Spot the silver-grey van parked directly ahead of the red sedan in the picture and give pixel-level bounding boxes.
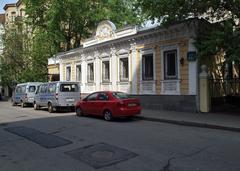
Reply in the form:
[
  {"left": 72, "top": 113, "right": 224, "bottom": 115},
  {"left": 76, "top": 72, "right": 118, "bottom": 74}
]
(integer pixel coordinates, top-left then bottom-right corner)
[{"left": 33, "top": 81, "right": 81, "bottom": 113}]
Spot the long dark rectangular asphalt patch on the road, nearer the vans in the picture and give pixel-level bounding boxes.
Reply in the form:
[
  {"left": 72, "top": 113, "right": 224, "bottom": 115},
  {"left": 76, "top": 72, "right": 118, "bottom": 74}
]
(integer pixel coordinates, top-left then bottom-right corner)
[{"left": 5, "top": 126, "right": 72, "bottom": 148}]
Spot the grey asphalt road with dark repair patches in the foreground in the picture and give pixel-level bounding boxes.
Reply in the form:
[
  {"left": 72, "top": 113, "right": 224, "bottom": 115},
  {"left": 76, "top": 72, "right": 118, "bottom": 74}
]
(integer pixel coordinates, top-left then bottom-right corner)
[{"left": 0, "top": 102, "right": 240, "bottom": 171}]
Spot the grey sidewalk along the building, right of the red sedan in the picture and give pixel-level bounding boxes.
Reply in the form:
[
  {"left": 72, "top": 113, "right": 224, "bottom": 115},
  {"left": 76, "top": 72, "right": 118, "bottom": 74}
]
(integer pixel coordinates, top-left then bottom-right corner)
[{"left": 139, "top": 109, "right": 240, "bottom": 132}]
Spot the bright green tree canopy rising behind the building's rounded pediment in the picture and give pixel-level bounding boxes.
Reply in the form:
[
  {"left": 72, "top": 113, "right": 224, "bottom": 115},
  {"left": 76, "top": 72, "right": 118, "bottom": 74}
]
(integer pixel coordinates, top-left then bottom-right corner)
[{"left": 24, "top": 0, "right": 140, "bottom": 51}]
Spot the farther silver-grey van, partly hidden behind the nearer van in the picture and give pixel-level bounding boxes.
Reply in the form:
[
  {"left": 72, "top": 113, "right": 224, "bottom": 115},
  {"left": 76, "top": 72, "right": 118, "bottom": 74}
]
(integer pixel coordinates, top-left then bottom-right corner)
[{"left": 12, "top": 82, "right": 41, "bottom": 107}]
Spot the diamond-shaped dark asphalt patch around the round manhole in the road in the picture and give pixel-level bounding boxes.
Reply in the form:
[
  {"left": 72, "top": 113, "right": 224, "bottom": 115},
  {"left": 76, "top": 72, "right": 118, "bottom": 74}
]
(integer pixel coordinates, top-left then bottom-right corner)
[{"left": 66, "top": 143, "right": 137, "bottom": 169}]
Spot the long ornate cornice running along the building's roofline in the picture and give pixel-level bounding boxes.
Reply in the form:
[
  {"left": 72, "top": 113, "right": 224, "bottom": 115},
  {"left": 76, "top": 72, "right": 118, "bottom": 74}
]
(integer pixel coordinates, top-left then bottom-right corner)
[{"left": 52, "top": 18, "right": 206, "bottom": 62}]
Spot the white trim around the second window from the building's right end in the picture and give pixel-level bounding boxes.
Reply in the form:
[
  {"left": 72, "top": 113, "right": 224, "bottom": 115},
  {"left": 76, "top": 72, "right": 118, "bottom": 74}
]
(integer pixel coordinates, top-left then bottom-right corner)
[{"left": 140, "top": 49, "right": 156, "bottom": 82}]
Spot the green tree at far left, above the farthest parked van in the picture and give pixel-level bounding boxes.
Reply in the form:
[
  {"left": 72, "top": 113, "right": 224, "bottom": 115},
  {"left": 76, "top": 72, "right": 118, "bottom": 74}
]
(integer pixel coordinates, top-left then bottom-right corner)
[{"left": 0, "top": 18, "right": 31, "bottom": 87}]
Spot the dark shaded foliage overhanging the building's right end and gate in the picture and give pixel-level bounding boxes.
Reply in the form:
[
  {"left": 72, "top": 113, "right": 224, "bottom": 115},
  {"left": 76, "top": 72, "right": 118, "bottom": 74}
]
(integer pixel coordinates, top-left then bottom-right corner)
[{"left": 138, "top": 0, "right": 240, "bottom": 68}]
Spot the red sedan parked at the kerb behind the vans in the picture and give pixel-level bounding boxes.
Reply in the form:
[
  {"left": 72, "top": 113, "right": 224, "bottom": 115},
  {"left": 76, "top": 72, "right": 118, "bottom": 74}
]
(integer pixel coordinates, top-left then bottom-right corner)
[{"left": 75, "top": 91, "right": 142, "bottom": 121}]
